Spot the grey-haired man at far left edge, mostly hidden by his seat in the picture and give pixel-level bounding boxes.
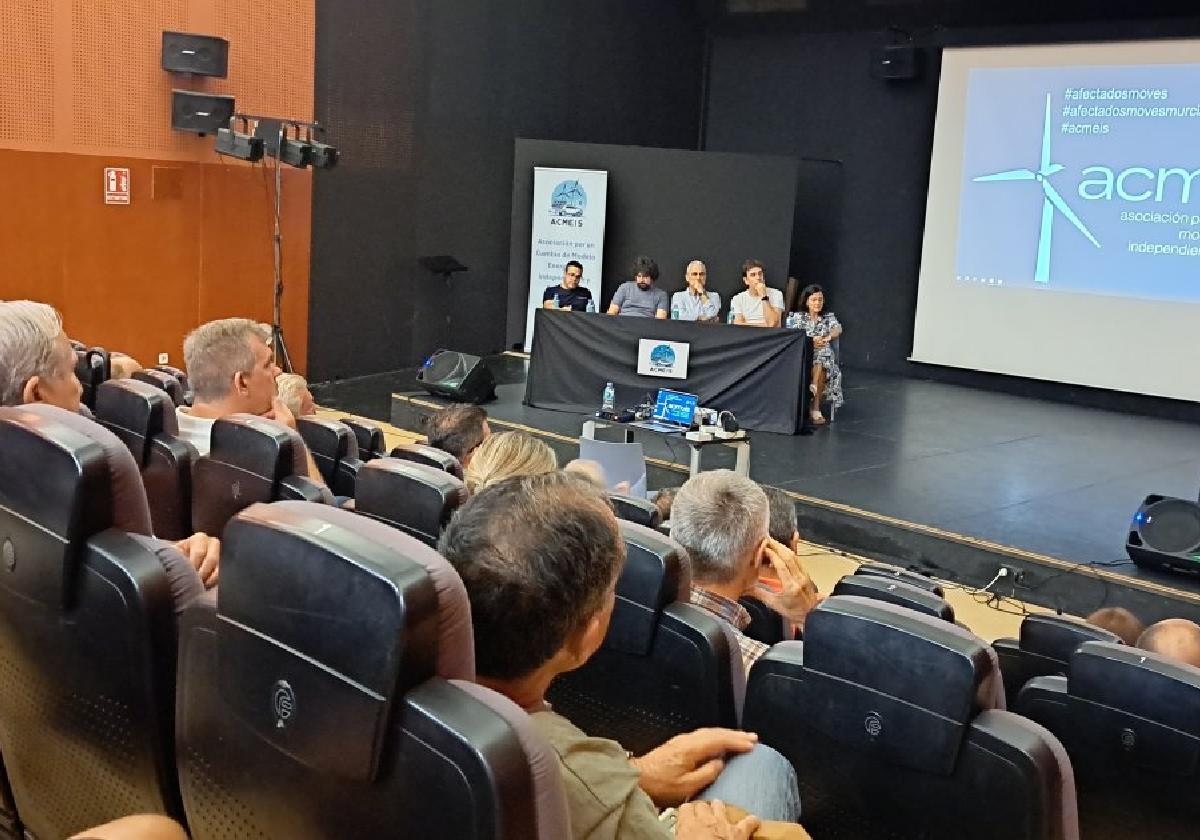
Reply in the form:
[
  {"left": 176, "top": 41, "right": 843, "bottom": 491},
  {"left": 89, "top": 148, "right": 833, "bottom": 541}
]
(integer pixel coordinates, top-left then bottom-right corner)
[{"left": 0, "top": 300, "right": 214, "bottom": 592}]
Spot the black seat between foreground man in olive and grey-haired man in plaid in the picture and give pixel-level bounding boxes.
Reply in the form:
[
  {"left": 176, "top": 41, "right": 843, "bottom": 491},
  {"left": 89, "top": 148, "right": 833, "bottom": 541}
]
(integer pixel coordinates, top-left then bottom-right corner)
[{"left": 547, "top": 522, "right": 745, "bottom": 754}]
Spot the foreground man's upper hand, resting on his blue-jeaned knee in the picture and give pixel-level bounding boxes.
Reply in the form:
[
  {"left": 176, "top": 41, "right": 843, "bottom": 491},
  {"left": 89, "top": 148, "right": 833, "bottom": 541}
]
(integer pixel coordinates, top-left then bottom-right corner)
[{"left": 630, "top": 728, "right": 758, "bottom": 808}]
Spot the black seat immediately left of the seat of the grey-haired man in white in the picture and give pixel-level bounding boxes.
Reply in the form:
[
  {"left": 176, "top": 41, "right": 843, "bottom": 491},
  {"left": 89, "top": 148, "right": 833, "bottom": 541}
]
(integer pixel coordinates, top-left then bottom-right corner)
[{"left": 96, "top": 379, "right": 196, "bottom": 541}]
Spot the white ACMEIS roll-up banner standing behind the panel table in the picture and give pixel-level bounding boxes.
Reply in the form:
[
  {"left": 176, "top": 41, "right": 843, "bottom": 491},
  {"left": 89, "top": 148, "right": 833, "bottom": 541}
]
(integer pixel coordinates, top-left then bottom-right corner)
[{"left": 526, "top": 167, "right": 608, "bottom": 352}]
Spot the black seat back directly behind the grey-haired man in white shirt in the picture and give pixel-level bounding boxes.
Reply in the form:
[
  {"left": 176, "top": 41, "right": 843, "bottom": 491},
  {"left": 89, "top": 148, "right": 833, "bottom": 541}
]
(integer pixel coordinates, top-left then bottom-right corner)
[{"left": 192, "top": 414, "right": 334, "bottom": 534}]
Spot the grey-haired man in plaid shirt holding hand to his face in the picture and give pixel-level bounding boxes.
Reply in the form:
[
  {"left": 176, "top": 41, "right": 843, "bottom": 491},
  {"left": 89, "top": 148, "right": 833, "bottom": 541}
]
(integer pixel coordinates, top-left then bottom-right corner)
[{"left": 671, "top": 469, "right": 818, "bottom": 674}]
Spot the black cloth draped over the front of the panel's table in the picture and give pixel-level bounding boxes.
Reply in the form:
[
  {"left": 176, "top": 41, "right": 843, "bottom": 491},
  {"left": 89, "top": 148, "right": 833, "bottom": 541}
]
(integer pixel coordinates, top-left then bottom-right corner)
[{"left": 524, "top": 310, "right": 812, "bottom": 434}]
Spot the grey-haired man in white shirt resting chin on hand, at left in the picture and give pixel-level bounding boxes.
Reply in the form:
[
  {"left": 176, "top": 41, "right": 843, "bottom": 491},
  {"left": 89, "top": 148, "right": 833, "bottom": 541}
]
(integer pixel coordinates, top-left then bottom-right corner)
[{"left": 175, "top": 318, "right": 325, "bottom": 486}]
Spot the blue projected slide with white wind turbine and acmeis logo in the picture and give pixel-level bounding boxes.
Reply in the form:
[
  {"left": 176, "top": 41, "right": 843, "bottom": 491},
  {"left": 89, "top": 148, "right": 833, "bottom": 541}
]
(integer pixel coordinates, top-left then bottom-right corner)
[{"left": 955, "top": 65, "right": 1200, "bottom": 302}]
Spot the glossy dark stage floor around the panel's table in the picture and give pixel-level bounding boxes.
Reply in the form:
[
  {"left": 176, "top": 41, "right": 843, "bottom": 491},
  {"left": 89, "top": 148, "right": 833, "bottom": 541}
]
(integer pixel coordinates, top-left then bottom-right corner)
[{"left": 314, "top": 354, "right": 1200, "bottom": 604}]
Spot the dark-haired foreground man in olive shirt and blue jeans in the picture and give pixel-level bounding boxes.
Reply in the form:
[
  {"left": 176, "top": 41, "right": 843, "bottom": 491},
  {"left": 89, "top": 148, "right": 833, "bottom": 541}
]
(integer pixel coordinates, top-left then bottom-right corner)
[{"left": 439, "top": 472, "right": 799, "bottom": 840}]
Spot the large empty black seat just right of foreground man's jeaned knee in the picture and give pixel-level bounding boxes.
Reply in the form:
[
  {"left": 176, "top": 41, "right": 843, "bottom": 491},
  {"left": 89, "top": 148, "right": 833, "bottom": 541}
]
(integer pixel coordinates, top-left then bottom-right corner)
[{"left": 743, "top": 596, "right": 1079, "bottom": 840}]
